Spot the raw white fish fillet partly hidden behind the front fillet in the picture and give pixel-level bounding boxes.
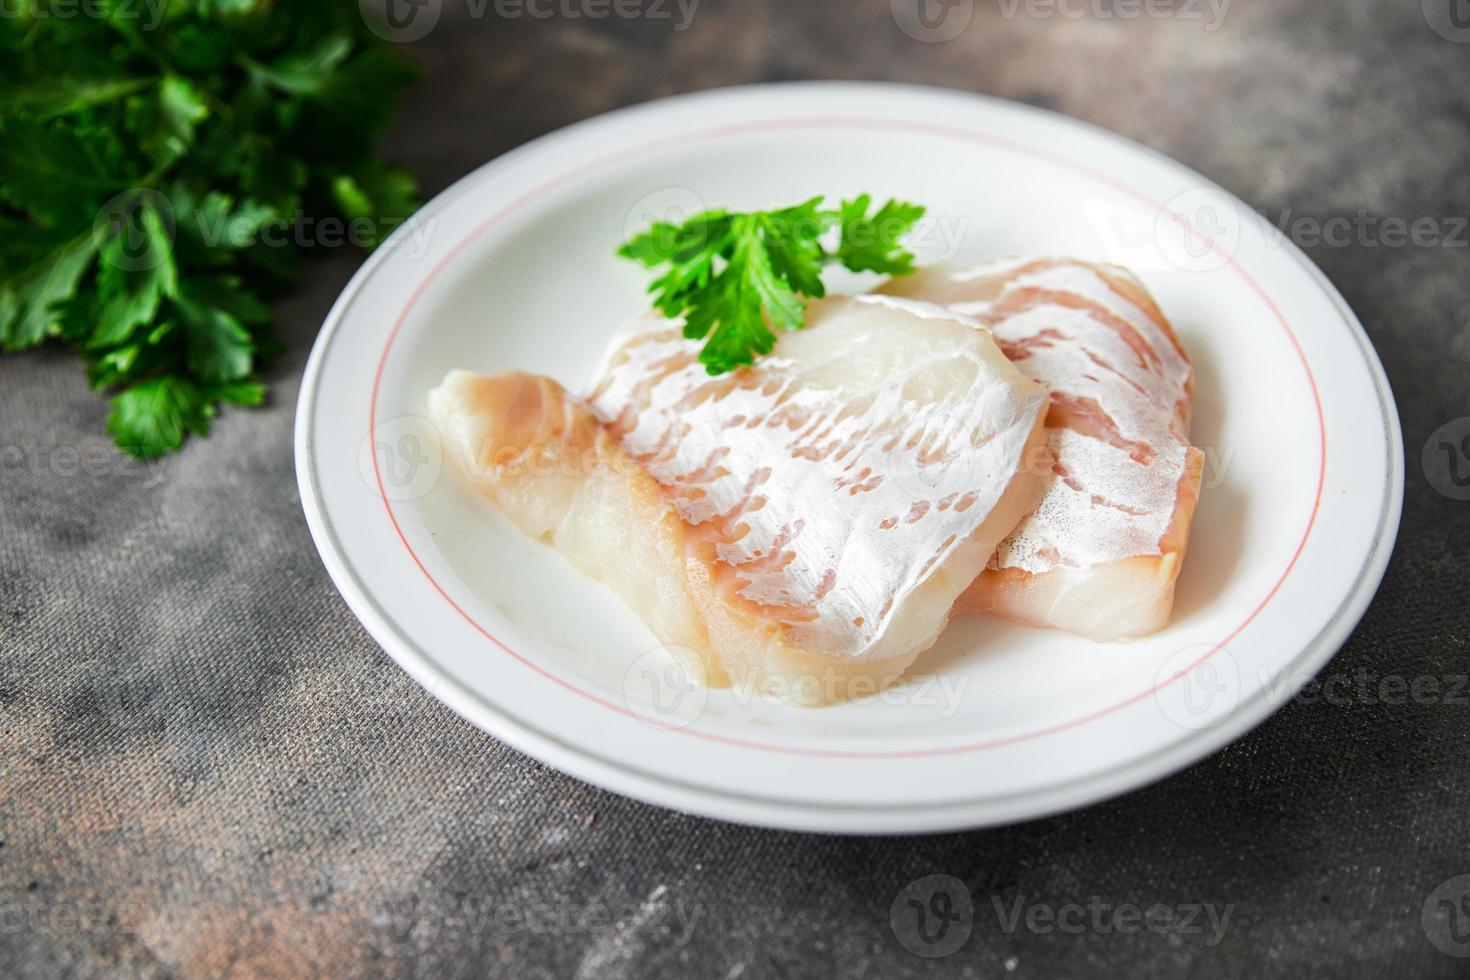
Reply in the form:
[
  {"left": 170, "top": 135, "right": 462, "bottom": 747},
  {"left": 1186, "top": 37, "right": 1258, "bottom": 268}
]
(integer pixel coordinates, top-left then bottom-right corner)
[{"left": 882, "top": 259, "right": 1204, "bottom": 641}]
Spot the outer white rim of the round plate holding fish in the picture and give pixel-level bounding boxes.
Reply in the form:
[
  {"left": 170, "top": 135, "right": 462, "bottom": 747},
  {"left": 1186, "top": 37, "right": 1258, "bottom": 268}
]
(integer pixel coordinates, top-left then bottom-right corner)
[{"left": 294, "top": 82, "right": 1404, "bottom": 833}]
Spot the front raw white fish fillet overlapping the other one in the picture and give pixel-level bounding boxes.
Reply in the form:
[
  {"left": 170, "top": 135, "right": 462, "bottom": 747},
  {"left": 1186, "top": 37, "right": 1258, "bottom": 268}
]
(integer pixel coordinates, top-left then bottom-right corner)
[{"left": 429, "top": 297, "right": 1048, "bottom": 704}]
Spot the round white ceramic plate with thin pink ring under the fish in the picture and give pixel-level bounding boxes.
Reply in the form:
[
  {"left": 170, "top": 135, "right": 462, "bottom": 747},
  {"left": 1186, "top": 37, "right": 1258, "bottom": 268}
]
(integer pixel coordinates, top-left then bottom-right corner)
[{"left": 297, "top": 84, "right": 1402, "bottom": 832}]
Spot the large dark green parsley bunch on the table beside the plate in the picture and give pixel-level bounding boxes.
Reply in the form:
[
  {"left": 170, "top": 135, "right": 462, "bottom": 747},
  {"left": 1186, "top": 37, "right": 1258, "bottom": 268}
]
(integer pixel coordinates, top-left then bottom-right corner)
[{"left": 0, "top": 0, "right": 416, "bottom": 458}]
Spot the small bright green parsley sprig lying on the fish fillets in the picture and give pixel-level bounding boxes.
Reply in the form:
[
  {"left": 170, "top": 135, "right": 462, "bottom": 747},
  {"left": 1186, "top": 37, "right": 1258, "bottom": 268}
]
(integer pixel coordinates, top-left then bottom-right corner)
[{"left": 617, "top": 194, "right": 925, "bottom": 375}]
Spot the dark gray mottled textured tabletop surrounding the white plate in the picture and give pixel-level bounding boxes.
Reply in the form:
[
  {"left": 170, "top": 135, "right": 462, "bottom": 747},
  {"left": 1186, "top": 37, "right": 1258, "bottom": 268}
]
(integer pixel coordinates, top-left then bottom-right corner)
[{"left": 0, "top": 0, "right": 1470, "bottom": 979}]
